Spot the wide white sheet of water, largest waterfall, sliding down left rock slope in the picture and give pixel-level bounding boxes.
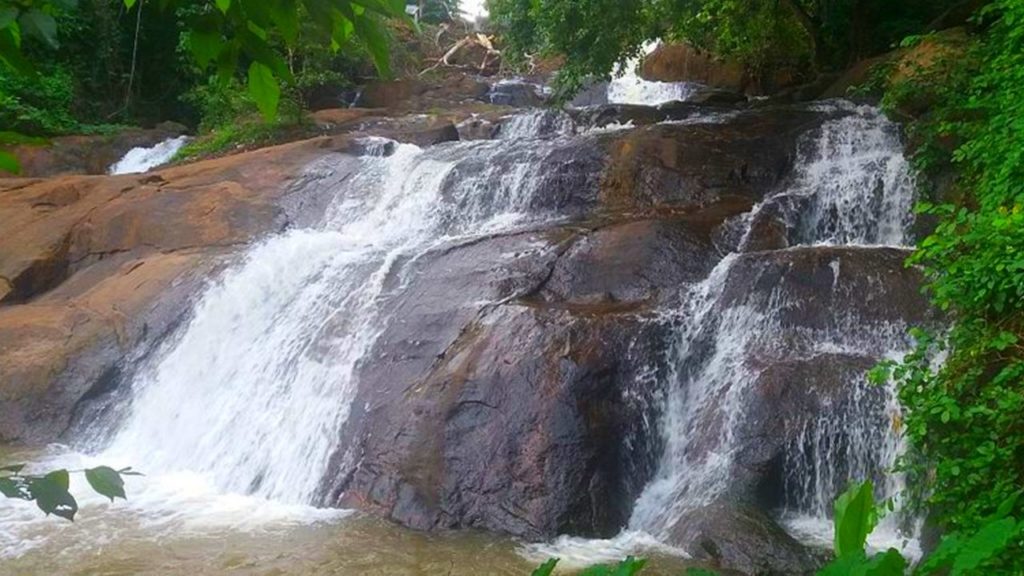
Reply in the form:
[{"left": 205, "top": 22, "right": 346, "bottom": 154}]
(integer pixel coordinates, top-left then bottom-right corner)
[{"left": 96, "top": 124, "right": 589, "bottom": 504}]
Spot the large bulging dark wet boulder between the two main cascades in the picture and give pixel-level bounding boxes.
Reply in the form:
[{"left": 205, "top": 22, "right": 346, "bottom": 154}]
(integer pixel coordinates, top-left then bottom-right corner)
[{"left": 328, "top": 225, "right": 673, "bottom": 539}]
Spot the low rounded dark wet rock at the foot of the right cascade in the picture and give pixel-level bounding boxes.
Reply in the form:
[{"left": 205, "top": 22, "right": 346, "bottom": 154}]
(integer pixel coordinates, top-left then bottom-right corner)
[{"left": 670, "top": 503, "right": 821, "bottom": 576}]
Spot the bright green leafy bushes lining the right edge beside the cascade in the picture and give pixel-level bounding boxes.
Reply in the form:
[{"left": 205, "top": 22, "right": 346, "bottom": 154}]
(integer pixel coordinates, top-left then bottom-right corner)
[{"left": 874, "top": 0, "right": 1024, "bottom": 574}]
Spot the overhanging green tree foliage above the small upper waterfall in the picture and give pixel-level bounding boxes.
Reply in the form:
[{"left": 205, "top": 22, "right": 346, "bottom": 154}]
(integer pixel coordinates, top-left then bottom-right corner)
[{"left": 487, "top": 0, "right": 954, "bottom": 95}]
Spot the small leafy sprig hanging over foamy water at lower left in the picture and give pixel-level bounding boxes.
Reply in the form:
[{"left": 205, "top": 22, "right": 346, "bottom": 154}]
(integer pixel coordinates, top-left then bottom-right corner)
[{"left": 0, "top": 464, "right": 139, "bottom": 521}]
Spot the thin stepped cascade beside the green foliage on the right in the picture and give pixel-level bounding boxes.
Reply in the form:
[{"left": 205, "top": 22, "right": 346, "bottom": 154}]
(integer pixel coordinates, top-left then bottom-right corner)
[{"left": 630, "top": 107, "right": 914, "bottom": 553}]
